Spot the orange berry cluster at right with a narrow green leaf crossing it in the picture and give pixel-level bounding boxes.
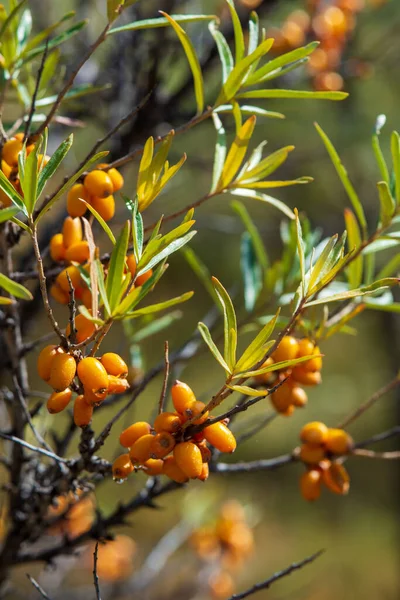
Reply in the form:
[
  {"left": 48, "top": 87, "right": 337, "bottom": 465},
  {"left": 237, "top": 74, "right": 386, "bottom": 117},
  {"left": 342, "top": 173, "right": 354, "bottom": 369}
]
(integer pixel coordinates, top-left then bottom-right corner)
[{"left": 255, "top": 335, "right": 322, "bottom": 416}]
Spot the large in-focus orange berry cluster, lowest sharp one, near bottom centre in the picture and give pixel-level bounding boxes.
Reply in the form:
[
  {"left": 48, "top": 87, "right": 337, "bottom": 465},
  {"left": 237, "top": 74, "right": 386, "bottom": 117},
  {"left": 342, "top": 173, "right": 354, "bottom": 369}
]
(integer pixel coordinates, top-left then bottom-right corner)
[{"left": 112, "top": 381, "right": 236, "bottom": 483}]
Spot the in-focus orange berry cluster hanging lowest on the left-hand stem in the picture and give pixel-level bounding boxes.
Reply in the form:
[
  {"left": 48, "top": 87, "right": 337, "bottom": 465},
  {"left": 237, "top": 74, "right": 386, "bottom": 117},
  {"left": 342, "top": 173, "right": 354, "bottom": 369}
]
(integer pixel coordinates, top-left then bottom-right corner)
[{"left": 37, "top": 344, "right": 129, "bottom": 427}]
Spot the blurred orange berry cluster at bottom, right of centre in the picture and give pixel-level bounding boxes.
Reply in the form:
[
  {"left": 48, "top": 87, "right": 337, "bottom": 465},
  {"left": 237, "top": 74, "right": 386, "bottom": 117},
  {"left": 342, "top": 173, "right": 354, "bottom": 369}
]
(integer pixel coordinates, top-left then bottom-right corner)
[{"left": 190, "top": 500, "right": 254, "bottom": 598}]
